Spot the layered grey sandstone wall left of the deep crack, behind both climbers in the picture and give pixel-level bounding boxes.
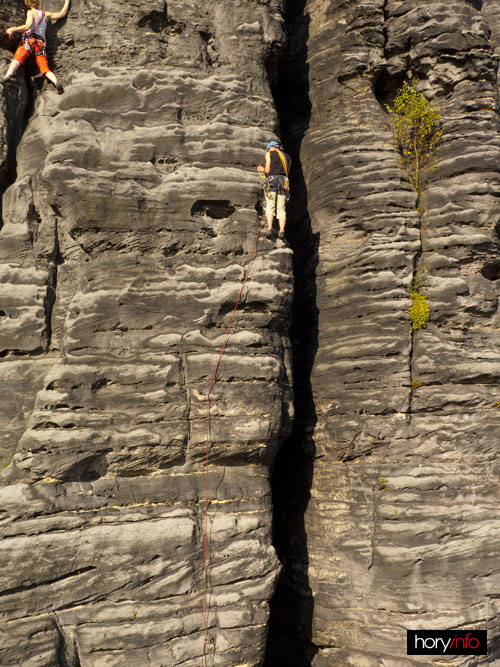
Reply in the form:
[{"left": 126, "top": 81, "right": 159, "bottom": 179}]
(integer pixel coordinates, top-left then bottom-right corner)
[{"left": 0, "top": 0, "right": 292, "bottom": 667}]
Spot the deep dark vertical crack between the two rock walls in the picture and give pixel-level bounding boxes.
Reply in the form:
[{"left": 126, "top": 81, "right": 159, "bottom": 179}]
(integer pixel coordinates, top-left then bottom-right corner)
[{"left": 264, "top": 0, "right": 319, "bottom": 667}]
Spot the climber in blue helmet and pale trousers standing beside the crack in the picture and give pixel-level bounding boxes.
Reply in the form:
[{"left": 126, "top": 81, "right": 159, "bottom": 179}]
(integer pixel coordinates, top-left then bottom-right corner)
[{"left": 257, "top": 141, "right": 292, "bottom": 241}]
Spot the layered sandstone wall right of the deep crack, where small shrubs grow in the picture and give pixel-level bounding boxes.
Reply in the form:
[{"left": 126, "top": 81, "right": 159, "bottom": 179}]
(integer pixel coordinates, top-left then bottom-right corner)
[{"left": 267, "top": 0, "right": 500, "bottom": 667}]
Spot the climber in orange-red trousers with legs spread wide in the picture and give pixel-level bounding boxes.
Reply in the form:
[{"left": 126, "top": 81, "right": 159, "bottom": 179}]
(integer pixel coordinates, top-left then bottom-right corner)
[{"left": 0, "top": 0, "right": 70, "bottom": 94}]
